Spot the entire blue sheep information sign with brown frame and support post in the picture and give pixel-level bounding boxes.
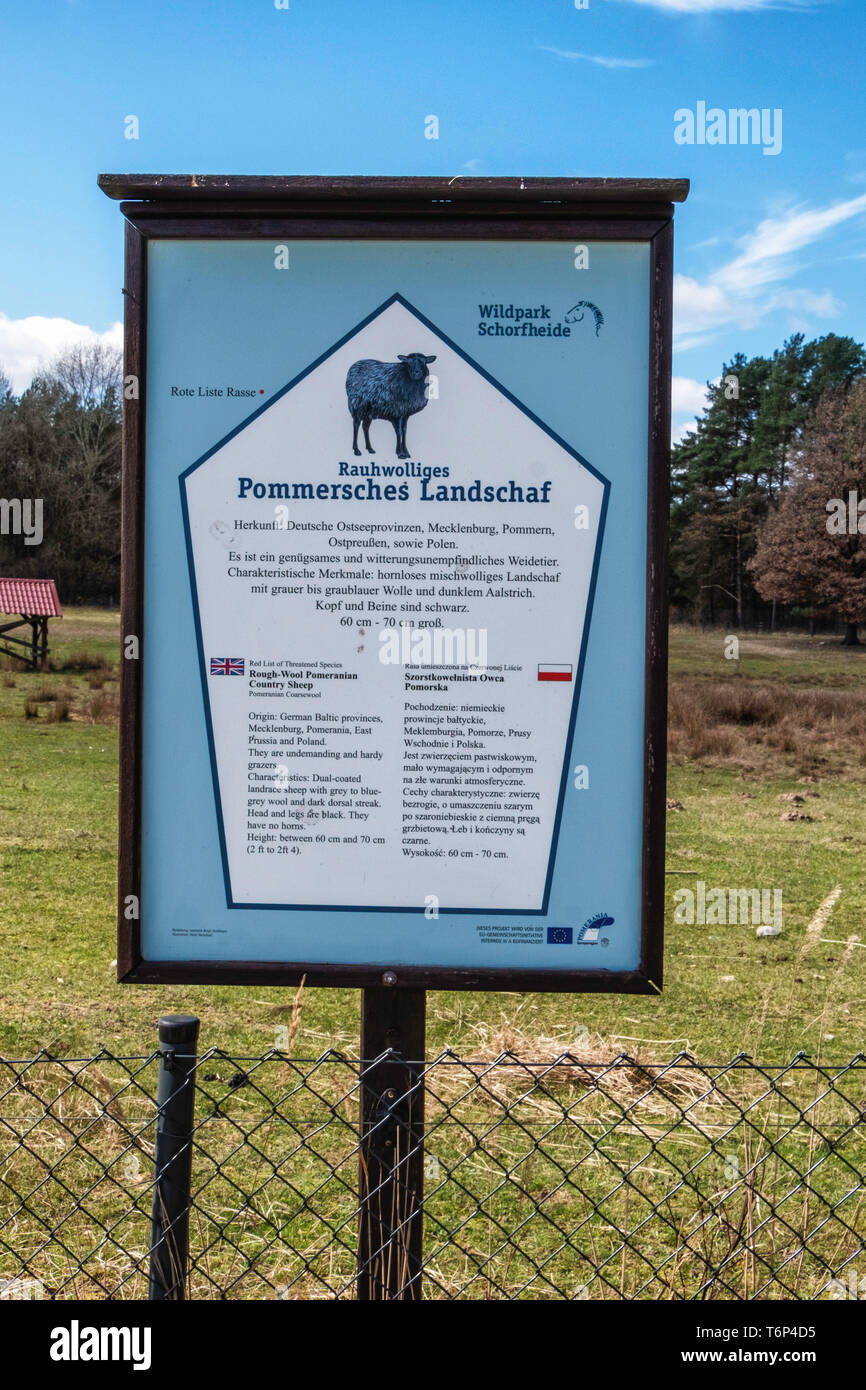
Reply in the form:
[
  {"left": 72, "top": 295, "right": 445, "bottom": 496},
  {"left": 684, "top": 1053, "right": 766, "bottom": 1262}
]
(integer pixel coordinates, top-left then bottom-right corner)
[{"left": 100, "top": 175, "right": 688, "bottom": 1298}]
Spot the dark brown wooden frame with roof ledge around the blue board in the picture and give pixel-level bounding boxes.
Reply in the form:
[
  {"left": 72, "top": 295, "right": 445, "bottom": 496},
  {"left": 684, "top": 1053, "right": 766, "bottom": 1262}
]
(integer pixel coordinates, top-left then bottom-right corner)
[{"left": 99, "top": 174, "right": 688, "bottom": 994}]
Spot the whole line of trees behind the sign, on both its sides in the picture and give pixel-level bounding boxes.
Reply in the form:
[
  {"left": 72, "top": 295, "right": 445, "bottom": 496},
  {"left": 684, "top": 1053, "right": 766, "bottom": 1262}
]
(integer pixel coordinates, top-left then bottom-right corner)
[{"left": 0, "top": 334, "right": 866, "bottom": 641}]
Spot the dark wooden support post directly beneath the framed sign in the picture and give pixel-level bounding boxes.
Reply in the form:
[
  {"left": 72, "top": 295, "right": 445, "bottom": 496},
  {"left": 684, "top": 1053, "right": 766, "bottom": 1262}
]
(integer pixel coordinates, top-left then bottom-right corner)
[{"left": 357, "top": 972, "right": 427, "bottom": 1302}]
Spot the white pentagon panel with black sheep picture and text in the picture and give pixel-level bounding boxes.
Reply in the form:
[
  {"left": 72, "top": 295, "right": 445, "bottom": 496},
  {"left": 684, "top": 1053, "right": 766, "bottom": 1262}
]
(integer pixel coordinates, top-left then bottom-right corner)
[{"left": 181, "top": 296, "right": 606, "bottom": 916}]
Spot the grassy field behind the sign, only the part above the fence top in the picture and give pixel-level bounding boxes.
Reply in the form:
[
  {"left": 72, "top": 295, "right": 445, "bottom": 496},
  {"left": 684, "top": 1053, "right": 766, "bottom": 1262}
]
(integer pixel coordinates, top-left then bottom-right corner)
[{"left": 0, "top": 609, "right": 866, "bottom": 1061}]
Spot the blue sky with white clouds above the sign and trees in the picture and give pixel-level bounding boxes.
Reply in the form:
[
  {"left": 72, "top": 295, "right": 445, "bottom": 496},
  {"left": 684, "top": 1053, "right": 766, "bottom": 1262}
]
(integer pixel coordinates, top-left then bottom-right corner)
[{"left": 0, "top": 0, "right": 866, "bottom": 434}]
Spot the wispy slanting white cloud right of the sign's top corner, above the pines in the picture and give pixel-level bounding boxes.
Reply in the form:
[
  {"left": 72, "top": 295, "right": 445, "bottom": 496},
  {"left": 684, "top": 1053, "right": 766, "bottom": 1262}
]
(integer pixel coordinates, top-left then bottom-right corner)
[{"left": 674, "top": 195, "right": 866, "bottom": 350}]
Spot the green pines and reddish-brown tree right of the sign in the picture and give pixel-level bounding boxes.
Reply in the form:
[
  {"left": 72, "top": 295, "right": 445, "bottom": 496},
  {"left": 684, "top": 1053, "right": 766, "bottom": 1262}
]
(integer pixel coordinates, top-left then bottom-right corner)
[{"left": 671, "top": 334, "right": 866, "bottom": 641}]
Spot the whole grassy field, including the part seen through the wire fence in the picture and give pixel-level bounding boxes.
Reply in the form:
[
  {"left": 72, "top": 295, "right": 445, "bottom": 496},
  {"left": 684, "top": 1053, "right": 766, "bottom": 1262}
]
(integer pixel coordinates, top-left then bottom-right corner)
[{"left": 0, "top": 609, "right": 866, "bottom": 1298}]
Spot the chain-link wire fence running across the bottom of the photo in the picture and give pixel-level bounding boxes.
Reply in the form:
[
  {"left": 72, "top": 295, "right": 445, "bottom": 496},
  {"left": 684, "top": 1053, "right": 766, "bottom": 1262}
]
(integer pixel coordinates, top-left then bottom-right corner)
[{"left": 0, "top": 1049, "right": 866, "bottom": 1300}]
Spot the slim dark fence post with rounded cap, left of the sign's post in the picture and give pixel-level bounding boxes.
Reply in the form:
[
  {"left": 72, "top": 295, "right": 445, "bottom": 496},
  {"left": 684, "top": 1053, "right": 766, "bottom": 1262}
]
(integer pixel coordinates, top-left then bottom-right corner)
[{"left": 147, "top": 1013, "right": 199, "bottom": 1301}]
